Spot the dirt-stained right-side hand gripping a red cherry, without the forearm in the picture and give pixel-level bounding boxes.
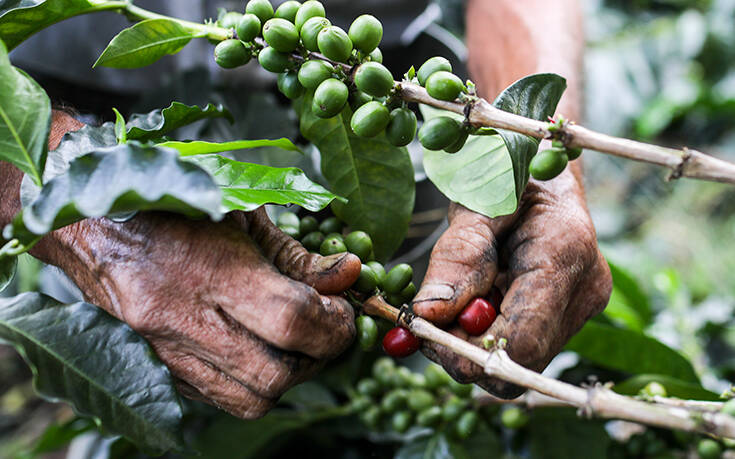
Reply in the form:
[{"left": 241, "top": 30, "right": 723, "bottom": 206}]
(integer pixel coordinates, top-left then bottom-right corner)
[{"left": 414, "top": 168, "right": 612, "bottom": 398}]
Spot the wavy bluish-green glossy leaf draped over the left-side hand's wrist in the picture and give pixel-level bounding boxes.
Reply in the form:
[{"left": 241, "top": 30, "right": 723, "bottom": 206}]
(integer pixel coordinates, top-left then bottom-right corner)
[{"left": 6, "top": 142, "right": 222, "bottom": 244}]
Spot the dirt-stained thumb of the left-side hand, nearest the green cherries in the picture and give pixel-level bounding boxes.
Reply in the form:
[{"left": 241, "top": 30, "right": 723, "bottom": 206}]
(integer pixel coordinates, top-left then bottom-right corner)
[{"left": 237, "top": 207, "right": 361, "bottom": 295}]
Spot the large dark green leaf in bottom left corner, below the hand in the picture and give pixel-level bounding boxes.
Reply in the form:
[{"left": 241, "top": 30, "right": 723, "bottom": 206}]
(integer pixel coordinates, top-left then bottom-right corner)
[{"left": 0, "top": 293, "right": 182, "bottom": 453}]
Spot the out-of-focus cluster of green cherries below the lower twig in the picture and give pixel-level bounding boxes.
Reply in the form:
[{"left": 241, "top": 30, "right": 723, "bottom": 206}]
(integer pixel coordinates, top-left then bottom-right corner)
[{"left": 350, "top": 357, "right": 479, "bottom": 439}]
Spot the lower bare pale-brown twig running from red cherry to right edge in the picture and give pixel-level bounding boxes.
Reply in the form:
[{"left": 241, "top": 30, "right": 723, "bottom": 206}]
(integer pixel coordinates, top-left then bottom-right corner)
[{"left": 363, "top": 295, "right": 735, "bottom": 438}]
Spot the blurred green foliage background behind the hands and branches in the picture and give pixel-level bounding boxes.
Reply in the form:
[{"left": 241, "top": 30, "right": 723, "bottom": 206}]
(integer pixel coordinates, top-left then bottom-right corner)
[{"left": 0, "top": 0, "right": 735, "bottom": 459}]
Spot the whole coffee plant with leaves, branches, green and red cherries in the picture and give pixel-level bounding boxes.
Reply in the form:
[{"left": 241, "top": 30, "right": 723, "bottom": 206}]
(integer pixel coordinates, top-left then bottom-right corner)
[{"left": 0, "top": 0, "right": 735, "bottom": 457}]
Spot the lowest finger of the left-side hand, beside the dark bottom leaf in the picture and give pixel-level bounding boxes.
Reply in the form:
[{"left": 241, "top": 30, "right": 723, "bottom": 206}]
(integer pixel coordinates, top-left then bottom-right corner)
[{"left": 161, "top": 346, "right": 276, "bottom": 419}]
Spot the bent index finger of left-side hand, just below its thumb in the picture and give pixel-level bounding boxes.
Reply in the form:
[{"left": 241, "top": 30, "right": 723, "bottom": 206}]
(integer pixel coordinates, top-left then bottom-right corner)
[{"left": 205, "top": 268, "right": 355, "bottom": 359}]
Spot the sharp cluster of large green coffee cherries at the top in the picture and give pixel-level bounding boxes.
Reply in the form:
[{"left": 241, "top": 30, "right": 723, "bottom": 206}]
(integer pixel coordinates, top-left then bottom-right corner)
[{"left": 214, "top": 0, "right": 417, "bottom": 146}]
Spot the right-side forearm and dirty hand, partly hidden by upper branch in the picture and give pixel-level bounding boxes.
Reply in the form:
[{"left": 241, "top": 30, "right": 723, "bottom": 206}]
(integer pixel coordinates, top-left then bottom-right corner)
[{"left": 414, "top": 0, "right": 611, "bottom": 397}]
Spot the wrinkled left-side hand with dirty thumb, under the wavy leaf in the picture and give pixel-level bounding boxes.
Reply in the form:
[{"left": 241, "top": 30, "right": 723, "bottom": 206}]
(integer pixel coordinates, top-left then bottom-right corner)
[{"left": 0, "top": 112, "right": 361, "bottom": 418}]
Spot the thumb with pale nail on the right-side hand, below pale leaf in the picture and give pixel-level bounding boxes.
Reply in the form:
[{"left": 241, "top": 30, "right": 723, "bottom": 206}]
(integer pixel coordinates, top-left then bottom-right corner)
[{"left": 413, "top": 205, "right": 514, "bottom": 324}]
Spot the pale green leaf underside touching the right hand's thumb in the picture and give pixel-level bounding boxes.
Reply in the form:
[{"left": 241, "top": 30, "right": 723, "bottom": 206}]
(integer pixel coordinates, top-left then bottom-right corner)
[{"left": 420, "top": 105, "right": 517, "bottom": 217}]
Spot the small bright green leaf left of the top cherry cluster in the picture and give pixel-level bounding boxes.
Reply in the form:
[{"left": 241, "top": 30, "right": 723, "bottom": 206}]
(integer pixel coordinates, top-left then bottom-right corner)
[{"left": 94, "top": 18, "right": 200, "bottom": 69}]
